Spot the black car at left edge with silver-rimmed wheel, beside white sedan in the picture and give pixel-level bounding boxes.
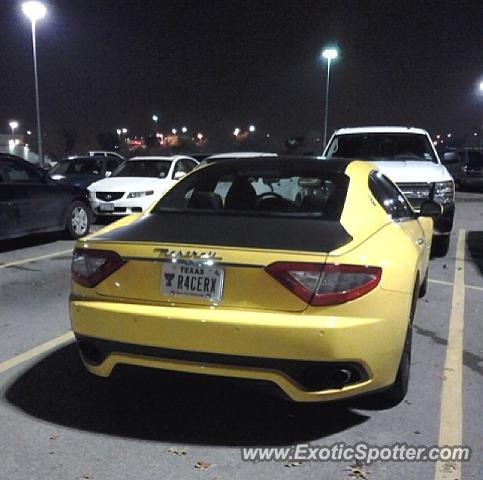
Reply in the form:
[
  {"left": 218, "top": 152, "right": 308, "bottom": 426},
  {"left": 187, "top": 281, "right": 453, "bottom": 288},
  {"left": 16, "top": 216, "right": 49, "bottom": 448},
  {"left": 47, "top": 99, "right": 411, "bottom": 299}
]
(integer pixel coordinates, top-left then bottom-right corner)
[{"left": 0, "top": 154, "right": 92, "bottom": 240}]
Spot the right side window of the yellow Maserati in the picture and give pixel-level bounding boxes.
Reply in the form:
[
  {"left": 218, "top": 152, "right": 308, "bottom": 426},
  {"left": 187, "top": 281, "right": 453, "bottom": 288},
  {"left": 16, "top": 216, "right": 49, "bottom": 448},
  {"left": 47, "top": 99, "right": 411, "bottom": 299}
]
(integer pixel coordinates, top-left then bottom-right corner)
[{"left": 369, "top": 172, "right": 414, "bottom": 220}]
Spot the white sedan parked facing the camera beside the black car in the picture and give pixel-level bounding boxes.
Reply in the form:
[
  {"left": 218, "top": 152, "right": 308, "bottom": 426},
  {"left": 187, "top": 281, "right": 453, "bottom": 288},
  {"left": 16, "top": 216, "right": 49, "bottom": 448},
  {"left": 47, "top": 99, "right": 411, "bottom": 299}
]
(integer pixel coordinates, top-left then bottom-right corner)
[{"left": 88, "top": 155, "right": 198, "bottom": 216}]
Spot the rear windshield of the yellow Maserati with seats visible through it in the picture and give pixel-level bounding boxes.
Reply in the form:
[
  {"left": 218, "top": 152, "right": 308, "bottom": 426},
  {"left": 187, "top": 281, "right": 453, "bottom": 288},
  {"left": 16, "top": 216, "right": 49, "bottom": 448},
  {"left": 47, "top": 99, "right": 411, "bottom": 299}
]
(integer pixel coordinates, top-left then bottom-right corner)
[{"left": 153, "top": 161, "right": 349, "bottom": 221}]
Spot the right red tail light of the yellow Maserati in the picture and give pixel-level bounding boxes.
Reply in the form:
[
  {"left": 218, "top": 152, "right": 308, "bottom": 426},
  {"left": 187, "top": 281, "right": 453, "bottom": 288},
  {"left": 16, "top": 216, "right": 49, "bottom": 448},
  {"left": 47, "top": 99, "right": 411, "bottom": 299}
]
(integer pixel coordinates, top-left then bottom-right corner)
[{"left": 265, "top": 262, "right": 382, "bottom": 306}]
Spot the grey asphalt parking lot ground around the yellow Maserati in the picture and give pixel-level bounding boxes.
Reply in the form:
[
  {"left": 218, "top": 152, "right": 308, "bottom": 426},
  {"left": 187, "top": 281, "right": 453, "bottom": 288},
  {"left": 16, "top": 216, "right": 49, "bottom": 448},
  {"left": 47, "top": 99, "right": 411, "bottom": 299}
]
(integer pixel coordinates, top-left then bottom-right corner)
[{"left": 0, "top": 192, "right": 483, "bottom": 480}]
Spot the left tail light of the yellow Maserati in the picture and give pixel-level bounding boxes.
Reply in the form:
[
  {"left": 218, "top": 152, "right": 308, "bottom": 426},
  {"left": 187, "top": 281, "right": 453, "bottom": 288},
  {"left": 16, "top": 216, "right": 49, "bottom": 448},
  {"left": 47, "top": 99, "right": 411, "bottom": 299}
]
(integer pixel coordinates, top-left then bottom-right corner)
[{"left": 71, "top": 248, "right": 126, "bottom": 288}]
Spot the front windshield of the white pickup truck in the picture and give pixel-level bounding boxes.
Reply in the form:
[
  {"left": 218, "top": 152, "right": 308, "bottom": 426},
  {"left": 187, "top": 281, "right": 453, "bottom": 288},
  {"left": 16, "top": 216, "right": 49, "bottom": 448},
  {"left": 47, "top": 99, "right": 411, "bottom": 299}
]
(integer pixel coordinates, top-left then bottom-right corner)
[{"left": 326, "top": 133, "right": 437, "bottom": 163}]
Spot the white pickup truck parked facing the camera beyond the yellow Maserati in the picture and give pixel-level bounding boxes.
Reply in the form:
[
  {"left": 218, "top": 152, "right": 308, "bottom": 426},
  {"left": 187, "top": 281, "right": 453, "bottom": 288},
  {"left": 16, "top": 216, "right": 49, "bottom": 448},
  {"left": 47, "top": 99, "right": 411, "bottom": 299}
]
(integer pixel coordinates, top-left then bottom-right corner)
[{"left": 323, "top": 127, "right": 455, "bottom": 256}]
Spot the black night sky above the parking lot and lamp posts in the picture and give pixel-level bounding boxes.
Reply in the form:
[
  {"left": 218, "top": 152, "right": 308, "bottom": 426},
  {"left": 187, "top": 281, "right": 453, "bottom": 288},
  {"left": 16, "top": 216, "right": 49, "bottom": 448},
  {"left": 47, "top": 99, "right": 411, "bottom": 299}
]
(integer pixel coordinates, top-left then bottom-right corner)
[{"left": 0, "top": 0, "right": 483, "bottom": 145}]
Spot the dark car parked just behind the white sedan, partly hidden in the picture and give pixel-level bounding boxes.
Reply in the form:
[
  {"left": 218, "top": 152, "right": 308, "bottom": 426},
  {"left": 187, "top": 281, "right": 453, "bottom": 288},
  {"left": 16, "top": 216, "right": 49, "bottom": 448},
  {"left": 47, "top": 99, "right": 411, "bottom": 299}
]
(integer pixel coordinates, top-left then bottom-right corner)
[{"left": 49, "top": 156, "right": 122, "bottom": 188}]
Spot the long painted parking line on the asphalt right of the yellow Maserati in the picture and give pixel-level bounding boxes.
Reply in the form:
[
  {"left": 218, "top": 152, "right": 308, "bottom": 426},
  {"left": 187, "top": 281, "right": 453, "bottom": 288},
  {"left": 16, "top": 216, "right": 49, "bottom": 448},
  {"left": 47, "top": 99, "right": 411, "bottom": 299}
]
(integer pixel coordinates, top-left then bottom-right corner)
[{"left": 434, "top": 230, "right": 466, "bottom": 480}]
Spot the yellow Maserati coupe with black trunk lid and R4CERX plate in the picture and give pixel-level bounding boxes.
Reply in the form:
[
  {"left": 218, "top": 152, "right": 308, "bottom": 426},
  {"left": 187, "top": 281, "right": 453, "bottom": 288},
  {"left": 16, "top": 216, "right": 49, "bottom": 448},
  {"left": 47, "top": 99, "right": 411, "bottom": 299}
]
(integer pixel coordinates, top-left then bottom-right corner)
[{"left": 70, "top": 157, "right": 441, "bottom": 405}]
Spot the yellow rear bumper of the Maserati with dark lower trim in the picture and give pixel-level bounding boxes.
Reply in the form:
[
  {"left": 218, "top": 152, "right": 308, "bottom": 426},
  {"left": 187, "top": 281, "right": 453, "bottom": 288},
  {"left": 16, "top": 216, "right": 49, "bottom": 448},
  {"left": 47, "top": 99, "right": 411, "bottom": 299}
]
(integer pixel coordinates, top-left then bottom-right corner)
[{"left": 70, "top": 292, "right": 410, "bottom": 401}]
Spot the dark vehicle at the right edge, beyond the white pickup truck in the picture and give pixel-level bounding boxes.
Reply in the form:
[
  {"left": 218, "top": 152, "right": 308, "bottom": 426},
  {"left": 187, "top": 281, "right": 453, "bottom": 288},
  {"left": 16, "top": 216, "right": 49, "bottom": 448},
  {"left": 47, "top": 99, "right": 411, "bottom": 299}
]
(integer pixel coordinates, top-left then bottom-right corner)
[{"left": 443, "top": 148, "right": 483, "bottom": 188}]
